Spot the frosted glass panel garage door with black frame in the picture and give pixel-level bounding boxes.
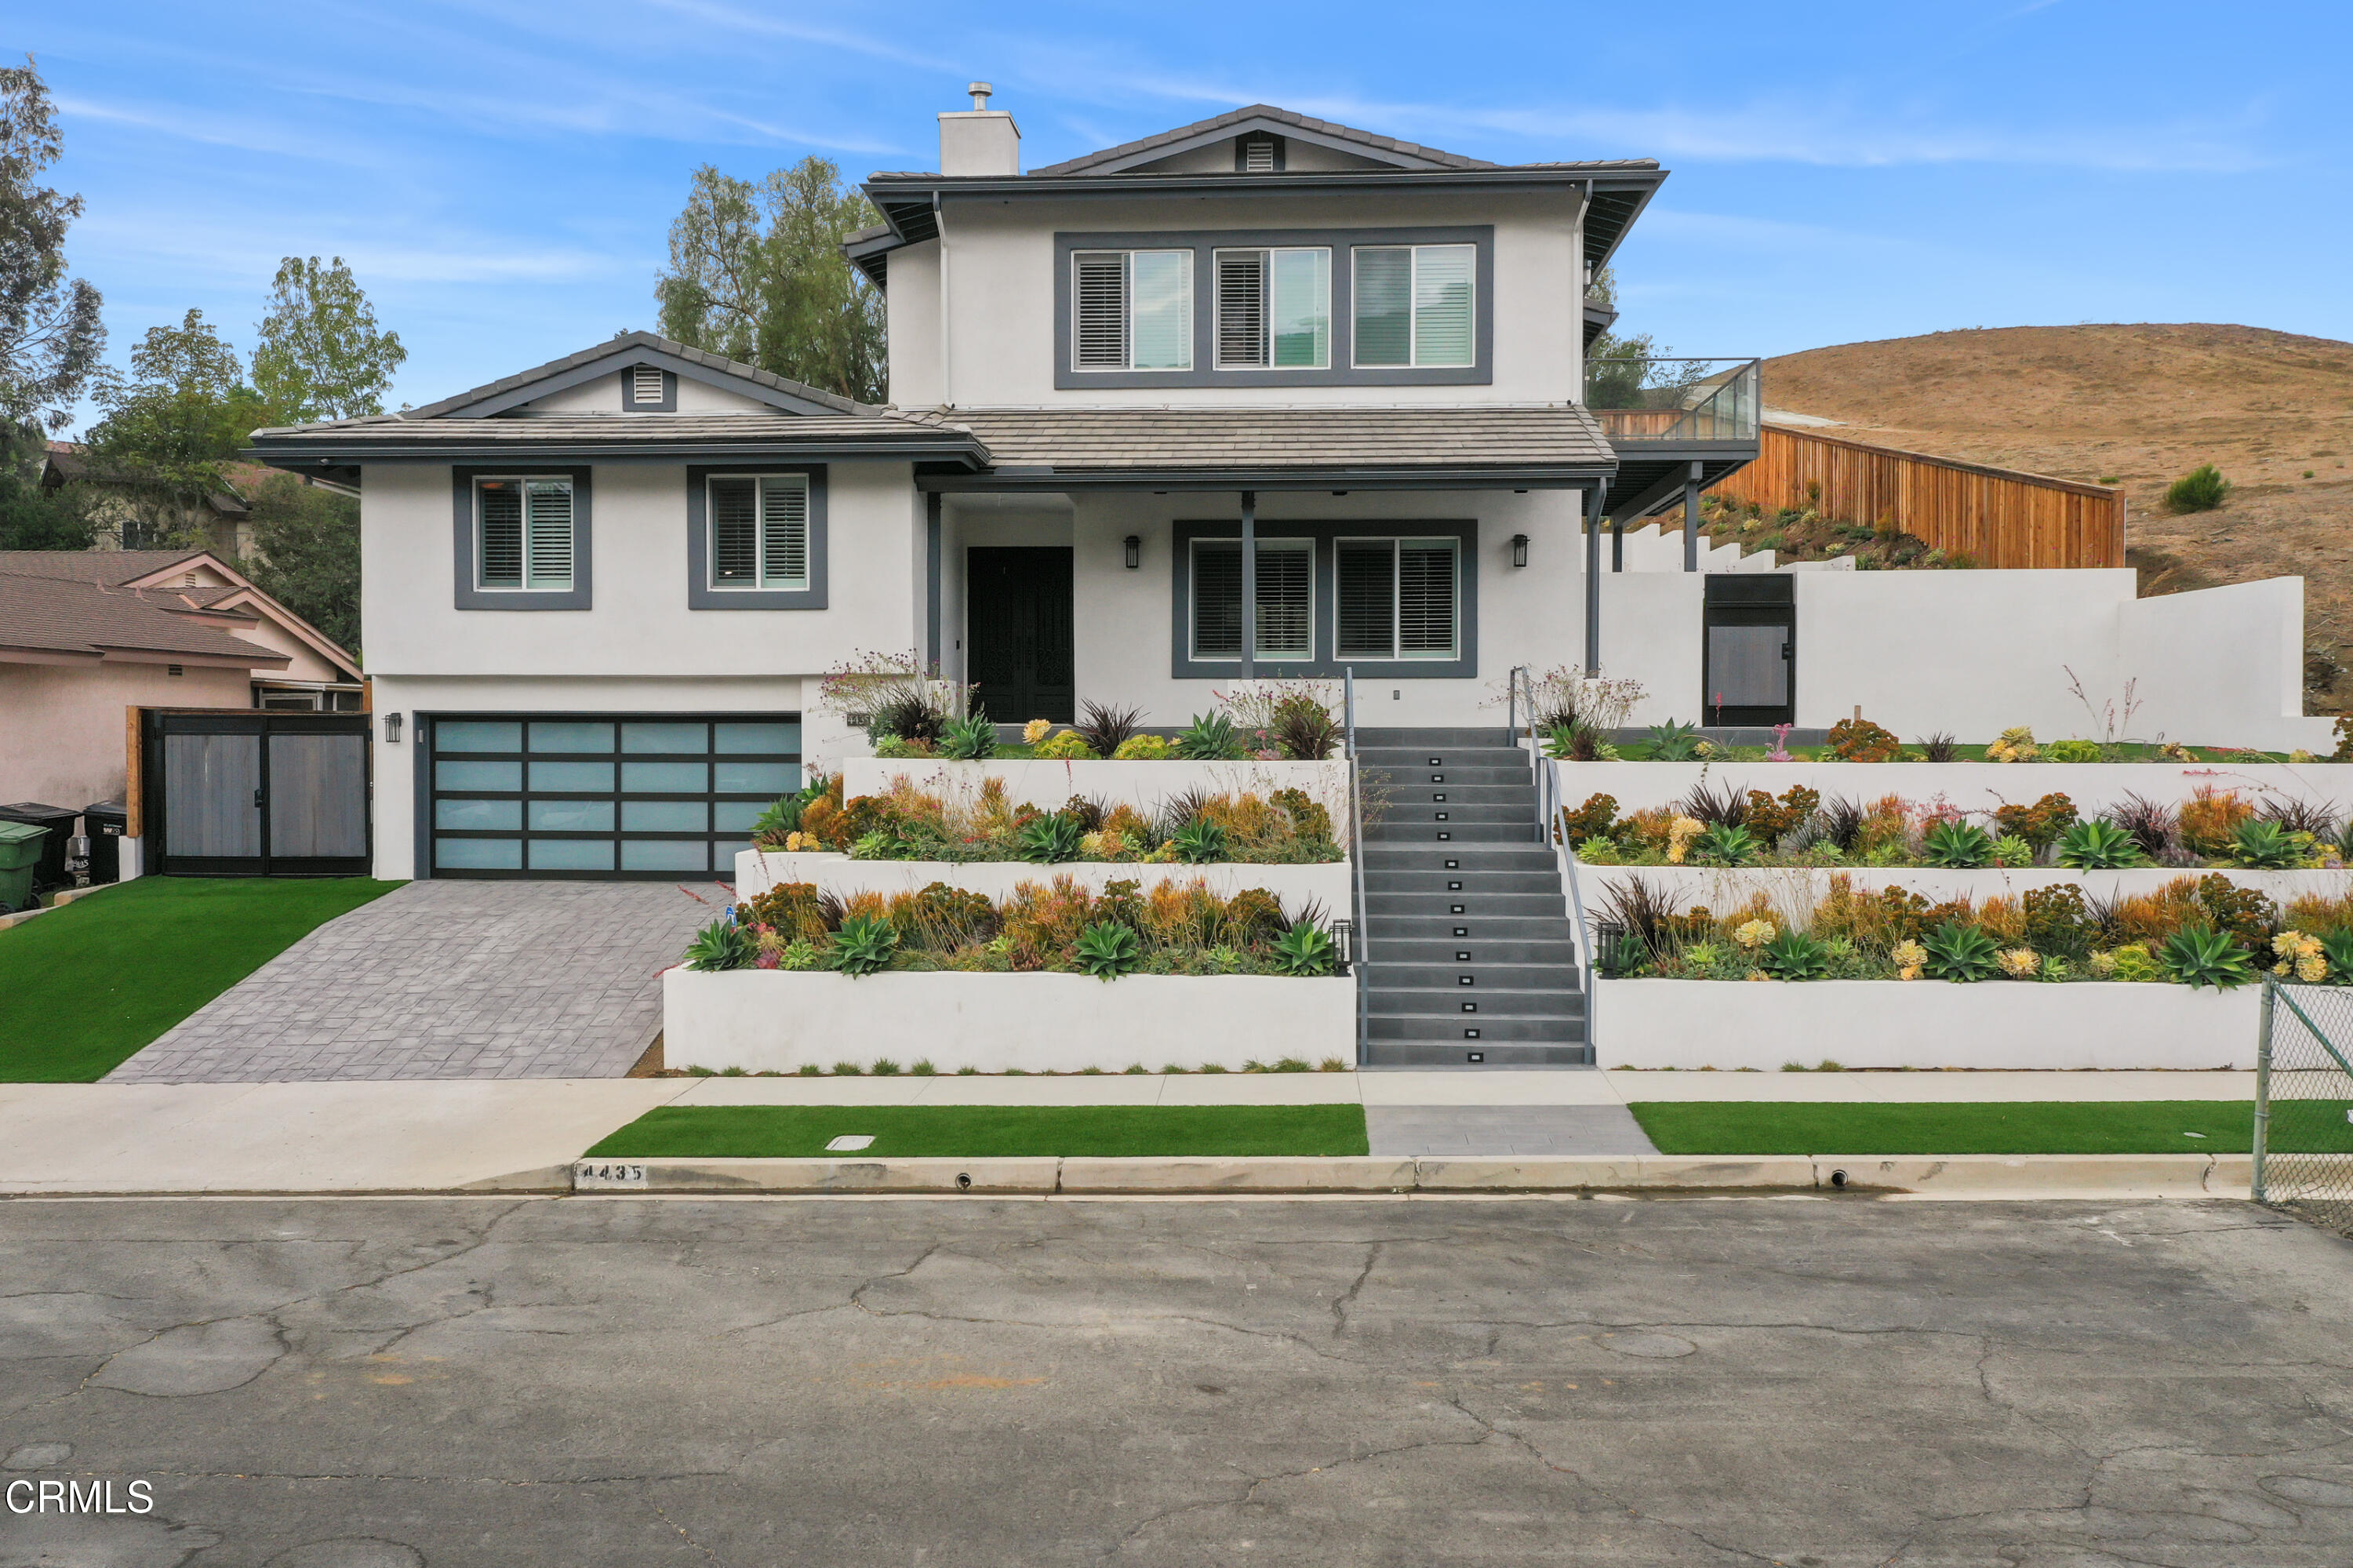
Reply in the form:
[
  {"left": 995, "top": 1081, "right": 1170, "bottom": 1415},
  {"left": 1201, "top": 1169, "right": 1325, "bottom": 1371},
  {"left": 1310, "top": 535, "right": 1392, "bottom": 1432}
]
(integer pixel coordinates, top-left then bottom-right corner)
[{"left": 426, "top": 713, "right": 800, "bottom": 881}]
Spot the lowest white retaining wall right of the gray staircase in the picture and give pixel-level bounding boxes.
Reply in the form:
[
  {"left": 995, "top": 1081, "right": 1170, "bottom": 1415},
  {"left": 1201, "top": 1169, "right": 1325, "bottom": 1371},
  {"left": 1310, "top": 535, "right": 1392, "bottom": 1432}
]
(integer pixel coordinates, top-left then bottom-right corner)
[{"left": 1593, "top": 980, "right": 2261, "bottom": 1068}]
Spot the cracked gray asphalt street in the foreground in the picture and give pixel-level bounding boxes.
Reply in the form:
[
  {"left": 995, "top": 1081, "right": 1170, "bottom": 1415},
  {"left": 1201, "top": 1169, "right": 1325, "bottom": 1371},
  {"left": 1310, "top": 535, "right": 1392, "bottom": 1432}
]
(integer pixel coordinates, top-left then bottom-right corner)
[{"left": 0, "top": 1199, "right": 2353, "bottom": 1568}]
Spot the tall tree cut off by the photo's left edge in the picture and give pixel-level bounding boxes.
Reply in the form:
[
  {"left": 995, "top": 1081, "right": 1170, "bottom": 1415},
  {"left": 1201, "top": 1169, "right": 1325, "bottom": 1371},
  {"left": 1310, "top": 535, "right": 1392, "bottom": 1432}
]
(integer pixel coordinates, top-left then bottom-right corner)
[{"left": 0, "top": 54, "right": 106, "bottom": 431}]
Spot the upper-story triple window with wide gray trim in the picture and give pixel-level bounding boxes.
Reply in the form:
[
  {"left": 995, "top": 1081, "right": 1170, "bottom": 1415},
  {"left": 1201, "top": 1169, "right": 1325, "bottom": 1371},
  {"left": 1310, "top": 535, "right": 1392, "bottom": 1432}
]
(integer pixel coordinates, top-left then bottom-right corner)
[{"left": 1054, "top": 224, "right": 1494, "bottom": 391}]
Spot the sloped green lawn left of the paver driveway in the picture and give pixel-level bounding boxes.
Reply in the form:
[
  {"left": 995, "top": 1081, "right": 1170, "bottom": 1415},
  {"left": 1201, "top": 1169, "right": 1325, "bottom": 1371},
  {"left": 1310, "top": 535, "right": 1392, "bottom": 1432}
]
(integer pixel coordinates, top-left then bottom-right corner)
[{"left": 0, "top": 876, "right": 400, "bottom": 1083}]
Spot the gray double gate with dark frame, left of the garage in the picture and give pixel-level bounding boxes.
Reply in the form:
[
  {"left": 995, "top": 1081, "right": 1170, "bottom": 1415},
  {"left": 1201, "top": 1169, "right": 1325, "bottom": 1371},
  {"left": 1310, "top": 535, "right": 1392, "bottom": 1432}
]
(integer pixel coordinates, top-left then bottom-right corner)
[{"left": 141, "top": 711, "right": 372, "bottom": 876}]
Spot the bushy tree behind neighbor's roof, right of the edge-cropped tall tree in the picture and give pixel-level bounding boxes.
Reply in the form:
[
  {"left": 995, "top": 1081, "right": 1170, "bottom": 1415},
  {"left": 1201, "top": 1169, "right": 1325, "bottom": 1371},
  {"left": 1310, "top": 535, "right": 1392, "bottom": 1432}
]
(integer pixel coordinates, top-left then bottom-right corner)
[{"left": 89, "top": 311, "right": 268, "bottom": 544}]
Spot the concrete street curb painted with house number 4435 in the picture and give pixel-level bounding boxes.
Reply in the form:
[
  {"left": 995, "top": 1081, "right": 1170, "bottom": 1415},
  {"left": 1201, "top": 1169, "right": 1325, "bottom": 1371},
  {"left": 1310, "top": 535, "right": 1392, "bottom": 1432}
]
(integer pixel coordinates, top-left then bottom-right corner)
[{"left": 574, "top": 1154, "right": 2252, "bottom": 1199}]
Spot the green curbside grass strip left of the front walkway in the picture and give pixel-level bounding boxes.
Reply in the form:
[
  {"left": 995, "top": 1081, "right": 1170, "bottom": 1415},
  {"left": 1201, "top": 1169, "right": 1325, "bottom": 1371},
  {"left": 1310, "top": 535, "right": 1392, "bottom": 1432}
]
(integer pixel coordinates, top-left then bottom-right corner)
[{"left": 588, "top": 1104, "right": 1369, "bottom": 1159}]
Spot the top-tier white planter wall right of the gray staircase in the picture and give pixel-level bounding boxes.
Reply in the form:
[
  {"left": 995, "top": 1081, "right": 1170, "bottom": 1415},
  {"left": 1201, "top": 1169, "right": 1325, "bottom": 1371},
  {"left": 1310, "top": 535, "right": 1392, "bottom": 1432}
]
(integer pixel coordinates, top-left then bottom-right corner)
[{"left": 1558, "top": 753, "right": 2353, "bottom": 817}]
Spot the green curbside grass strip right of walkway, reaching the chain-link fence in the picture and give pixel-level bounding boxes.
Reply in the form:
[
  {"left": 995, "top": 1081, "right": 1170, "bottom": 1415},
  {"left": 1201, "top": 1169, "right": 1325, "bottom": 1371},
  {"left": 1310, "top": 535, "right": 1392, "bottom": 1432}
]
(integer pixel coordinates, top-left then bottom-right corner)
[{"left": 1628, "top": 1100, "right": 2353, "bottom": 1154}]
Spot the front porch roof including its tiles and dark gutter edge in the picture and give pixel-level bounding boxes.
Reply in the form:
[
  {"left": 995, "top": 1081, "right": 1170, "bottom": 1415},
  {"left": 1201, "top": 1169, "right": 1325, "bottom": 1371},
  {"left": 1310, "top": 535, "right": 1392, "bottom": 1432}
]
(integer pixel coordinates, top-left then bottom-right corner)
[{"left": 915, "top": 402, "right": 1617, "bottom": 492}]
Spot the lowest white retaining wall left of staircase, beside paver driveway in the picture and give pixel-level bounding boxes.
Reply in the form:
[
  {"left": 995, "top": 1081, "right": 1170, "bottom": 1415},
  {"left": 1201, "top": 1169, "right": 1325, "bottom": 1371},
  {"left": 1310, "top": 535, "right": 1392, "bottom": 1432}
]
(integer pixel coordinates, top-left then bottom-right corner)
[{"left": 661, "top": 970, "right": 1355, "bottom": 1074}]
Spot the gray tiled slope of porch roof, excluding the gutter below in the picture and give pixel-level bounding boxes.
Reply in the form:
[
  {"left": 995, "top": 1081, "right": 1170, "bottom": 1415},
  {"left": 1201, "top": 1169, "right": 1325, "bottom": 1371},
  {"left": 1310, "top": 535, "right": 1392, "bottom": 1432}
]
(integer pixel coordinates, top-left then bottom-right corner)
[{"left": 955, "top": 405, "right": 1617, "bottom": 473}]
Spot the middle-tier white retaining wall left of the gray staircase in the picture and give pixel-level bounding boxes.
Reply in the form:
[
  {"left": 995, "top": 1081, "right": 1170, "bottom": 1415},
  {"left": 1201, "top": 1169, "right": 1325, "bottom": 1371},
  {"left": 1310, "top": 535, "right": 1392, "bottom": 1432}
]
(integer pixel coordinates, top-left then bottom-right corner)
[{"left": 736, "top": 850, "right": 1353, "bottom": 919}]
